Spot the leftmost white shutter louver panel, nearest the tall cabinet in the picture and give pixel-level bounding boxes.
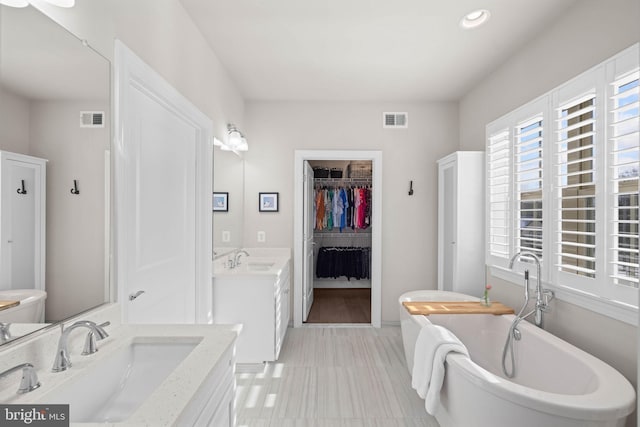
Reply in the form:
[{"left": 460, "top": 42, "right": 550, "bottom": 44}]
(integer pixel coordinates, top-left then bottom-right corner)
[{"left": 487, "top": 130, "right": 511, "bottom": 258}]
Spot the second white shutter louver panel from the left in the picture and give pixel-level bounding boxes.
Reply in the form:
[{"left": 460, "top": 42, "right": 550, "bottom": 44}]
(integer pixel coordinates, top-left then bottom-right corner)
[{"left": 514, "top": 114, "right": 542, "bottom": 259}]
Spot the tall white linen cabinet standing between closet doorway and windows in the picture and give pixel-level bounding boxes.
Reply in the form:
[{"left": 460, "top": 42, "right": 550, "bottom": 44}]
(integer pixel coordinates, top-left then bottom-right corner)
[{"left": 438, "top": 151, "right": 485, "bottom": 296}]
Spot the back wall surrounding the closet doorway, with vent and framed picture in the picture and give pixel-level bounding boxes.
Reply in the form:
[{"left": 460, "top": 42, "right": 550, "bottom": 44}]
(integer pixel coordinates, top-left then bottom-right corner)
[{"left": 244, "top": 101, "right": 458, "bottom": 322}]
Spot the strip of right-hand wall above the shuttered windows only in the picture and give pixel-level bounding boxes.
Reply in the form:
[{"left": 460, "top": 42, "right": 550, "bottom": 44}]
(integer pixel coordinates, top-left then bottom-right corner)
[{"left": 460, "top": 0, "right": 640, "bottom": 150}]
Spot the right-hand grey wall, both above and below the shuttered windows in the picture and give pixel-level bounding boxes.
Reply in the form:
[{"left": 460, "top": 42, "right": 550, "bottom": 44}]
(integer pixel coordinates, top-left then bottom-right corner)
[{"left": 459, "top": 0, "right": 640, "bottom": 426}]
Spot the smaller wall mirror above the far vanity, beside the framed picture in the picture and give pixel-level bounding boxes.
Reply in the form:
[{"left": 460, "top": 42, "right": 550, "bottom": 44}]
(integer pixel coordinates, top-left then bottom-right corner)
[{"left": 212, "top": 147, "right": 244, "bottom": 257}]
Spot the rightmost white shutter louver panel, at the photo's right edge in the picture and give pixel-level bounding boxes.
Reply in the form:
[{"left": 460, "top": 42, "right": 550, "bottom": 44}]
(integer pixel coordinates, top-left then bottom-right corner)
[{"left": 609, "top": 72, "right": 640, "bottom": 288}]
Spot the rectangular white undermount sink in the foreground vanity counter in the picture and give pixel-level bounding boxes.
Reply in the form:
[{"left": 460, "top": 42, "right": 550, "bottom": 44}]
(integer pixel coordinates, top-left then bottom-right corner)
[{"left": 47, "top": 337, "right": 201, "bottom": 423}]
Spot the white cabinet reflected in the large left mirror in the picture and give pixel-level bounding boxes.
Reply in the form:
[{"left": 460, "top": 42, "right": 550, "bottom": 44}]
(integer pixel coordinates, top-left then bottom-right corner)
[{"left": 0, "top": 151, "right": 47, "bottom": 291}]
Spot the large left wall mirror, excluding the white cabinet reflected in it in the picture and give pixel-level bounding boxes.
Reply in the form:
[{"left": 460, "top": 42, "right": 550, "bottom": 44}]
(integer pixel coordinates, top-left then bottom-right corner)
[{"left": 0, "top": 6, "right": 111, "bottom": 341}]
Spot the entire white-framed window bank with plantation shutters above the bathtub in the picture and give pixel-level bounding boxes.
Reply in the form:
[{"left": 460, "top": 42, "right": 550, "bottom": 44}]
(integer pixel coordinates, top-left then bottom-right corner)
[{"left": 486, "top": 44, "right": 640, "bottom": 324}]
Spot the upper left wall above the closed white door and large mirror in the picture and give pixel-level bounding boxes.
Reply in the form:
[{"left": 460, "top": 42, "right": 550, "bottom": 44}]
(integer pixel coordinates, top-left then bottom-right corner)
[{"left": 32, "top": 0, "right": 244, "bottom": 139}]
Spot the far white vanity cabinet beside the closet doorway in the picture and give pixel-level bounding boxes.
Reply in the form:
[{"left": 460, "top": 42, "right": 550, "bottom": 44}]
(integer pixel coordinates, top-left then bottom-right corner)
[{"left": 213, "top": 257, "right": 290, "bottom": 364}]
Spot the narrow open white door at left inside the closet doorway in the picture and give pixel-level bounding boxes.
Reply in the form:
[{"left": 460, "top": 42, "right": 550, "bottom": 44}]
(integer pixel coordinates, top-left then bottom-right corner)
[{"left": 302, "top": 160, "right": 315, "bottom": 322}]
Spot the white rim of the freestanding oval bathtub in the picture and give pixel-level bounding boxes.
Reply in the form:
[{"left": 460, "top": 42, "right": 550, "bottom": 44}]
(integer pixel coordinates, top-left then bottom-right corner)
[{"left": 398, "top": 290, "right": 636, "bottom": 421}]
